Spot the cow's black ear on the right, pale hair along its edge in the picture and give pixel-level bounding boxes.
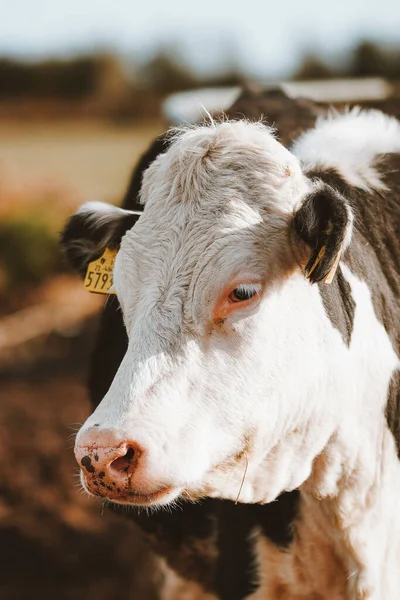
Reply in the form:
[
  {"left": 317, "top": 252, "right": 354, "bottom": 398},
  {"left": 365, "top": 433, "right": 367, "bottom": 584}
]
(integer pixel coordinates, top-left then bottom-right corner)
[{"left": 293, "top": 182, "right": 352, "bottom": 283}]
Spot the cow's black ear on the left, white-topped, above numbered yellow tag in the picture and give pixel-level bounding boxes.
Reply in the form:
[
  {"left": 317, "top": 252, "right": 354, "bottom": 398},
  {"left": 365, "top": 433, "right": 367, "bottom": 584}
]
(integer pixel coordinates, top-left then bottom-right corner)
[{"left": 61, "top": 202, "right": 140, "bottom": 275}]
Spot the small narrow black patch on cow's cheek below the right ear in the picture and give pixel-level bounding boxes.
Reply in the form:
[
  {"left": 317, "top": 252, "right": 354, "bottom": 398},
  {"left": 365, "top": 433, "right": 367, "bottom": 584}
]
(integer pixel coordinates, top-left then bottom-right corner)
[{"left": 318, "top": 267, "right": 356, "bottom": 346}]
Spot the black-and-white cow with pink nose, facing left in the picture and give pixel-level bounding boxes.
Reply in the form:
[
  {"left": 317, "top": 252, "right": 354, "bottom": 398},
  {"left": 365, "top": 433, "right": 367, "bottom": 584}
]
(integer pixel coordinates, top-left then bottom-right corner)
[{"left": 63, "top": 90, "right": 400, "bottom": 600}]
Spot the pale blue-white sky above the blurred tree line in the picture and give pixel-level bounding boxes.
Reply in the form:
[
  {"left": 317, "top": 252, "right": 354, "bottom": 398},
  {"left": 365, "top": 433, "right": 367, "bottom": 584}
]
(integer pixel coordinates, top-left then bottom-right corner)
[{"left": 0, "top": 0, "right": 400, "bottom": 77}]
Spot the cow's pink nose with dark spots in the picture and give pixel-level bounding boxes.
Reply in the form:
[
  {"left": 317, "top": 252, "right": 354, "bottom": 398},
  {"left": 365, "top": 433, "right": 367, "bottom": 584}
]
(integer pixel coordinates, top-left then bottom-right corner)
[{"left": 75, "top": 428, "right": 143, "bottom": 500}]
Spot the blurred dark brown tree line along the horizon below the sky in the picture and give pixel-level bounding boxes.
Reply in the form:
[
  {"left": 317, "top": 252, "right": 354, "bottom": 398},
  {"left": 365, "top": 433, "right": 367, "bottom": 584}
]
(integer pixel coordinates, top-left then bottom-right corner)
[{"left": 0, "top": 41, "right": 400, "bottom": 119}]
